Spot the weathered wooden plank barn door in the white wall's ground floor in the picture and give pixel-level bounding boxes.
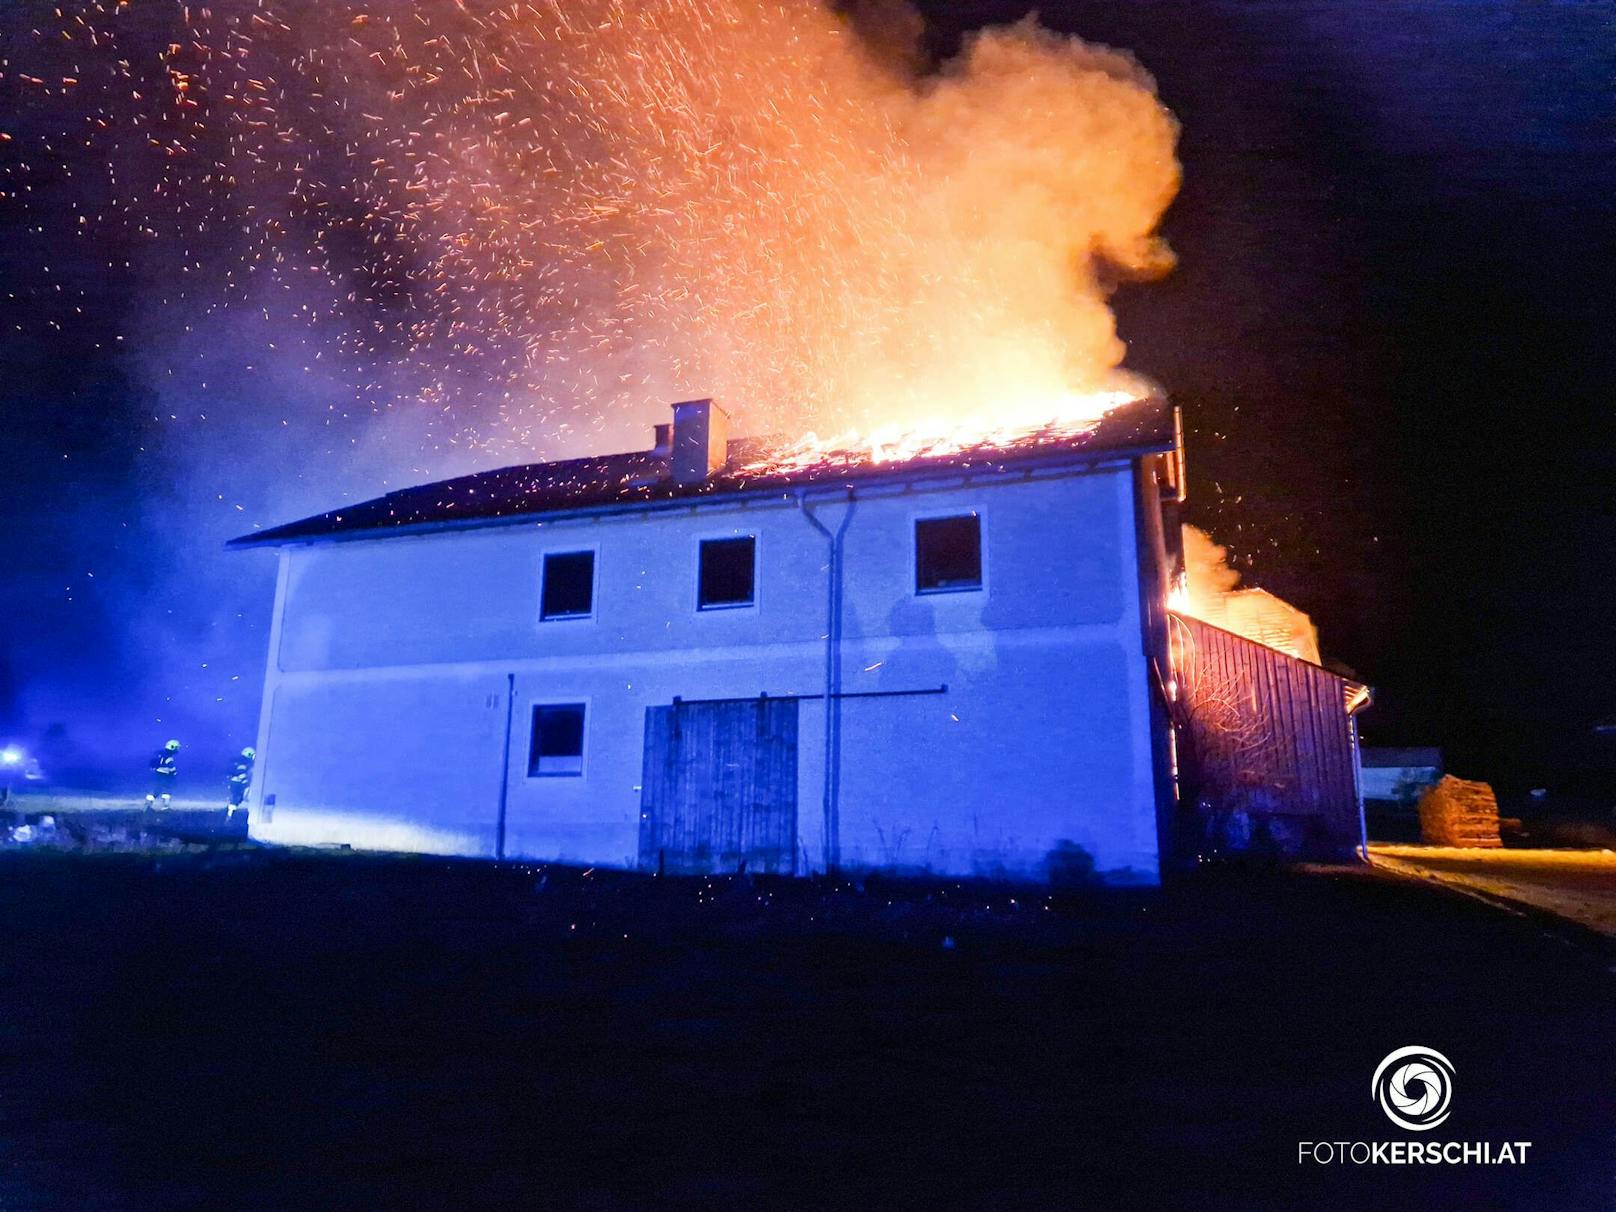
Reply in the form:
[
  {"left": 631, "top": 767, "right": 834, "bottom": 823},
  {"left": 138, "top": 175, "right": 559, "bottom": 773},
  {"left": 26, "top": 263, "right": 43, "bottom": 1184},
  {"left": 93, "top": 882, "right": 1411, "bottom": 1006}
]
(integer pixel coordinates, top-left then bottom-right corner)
[{"left": 640, "top": 698, "right": 797, "bottom": 874}]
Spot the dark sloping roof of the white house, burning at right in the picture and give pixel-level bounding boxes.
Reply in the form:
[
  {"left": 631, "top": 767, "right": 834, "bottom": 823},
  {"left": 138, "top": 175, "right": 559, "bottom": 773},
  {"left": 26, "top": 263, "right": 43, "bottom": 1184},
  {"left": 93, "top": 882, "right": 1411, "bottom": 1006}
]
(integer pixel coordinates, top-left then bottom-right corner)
[{"left": 228, "top": 398, "right": 1175, "bottom": 548}]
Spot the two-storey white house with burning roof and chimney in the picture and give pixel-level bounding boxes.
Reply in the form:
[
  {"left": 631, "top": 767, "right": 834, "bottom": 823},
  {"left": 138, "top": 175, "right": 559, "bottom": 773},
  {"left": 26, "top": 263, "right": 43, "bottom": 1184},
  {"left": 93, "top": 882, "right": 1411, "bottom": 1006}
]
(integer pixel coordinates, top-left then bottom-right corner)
[{"left": 234, "top": 398, "right": 1351, "bottom": 882}]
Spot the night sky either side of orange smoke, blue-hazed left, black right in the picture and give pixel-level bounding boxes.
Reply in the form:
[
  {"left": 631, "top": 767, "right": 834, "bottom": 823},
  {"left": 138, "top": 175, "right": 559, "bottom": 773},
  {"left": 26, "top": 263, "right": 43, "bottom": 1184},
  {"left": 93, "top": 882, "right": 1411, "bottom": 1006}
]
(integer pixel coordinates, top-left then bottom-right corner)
[{"left": 0, "top": 0, "right": 1616, "bottom": 795}]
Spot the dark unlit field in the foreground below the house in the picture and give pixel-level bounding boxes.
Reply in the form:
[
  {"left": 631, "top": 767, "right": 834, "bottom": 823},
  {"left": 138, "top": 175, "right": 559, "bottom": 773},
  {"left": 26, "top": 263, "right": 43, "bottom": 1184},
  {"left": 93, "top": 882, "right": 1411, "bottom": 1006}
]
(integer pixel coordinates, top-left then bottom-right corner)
[{"left": 0, "top": 852, "right": 1616, "bottom": 1209}]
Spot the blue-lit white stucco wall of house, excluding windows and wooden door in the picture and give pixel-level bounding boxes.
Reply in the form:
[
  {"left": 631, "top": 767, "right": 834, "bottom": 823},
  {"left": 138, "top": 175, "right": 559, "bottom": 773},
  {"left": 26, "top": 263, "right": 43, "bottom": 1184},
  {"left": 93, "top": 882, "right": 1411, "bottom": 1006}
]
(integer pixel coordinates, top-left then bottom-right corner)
[{"left": 252, "top": 467, "right": 1157, "bottom": 879}]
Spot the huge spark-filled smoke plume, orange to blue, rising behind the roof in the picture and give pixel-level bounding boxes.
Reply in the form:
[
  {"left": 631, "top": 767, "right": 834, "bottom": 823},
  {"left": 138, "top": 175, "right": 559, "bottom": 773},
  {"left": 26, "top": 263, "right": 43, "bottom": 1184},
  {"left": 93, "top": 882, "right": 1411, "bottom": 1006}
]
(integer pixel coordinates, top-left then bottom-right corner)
[{"left": 0, "top": 0, "right": 1178, "bottom": 778}]
